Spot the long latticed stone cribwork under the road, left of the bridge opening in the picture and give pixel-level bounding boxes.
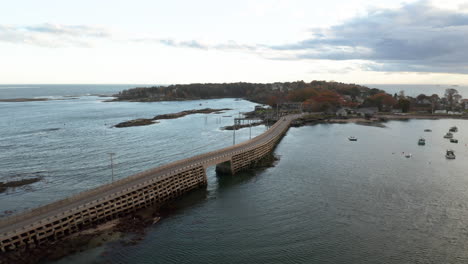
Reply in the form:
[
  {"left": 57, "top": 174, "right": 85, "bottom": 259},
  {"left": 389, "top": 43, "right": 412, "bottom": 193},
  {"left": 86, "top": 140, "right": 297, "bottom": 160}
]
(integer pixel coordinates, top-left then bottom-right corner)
[{"left": 0, "top": 166, "right": 207, "bottom": 252}]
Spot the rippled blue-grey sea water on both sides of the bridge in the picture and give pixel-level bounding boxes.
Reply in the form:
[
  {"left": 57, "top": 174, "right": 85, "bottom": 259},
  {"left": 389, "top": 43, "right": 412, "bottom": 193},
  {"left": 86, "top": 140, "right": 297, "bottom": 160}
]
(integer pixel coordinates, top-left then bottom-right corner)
[{"left": 0, "top": 85, "right": 468, "bottom": 264}]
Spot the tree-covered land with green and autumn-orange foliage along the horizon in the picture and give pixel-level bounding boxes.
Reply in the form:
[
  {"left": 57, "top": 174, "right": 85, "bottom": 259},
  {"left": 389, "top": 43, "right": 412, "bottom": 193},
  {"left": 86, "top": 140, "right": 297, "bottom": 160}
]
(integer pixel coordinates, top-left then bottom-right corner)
[{"left": 115, "top": 81, "right": 468, "bottom": 114}]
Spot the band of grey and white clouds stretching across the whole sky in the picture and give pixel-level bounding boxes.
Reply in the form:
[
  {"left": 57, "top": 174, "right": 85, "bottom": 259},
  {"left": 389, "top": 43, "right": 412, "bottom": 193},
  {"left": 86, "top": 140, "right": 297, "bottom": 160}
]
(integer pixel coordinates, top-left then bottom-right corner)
[{"left": 0, "top": 1, "right": 468, "bottom": 74}]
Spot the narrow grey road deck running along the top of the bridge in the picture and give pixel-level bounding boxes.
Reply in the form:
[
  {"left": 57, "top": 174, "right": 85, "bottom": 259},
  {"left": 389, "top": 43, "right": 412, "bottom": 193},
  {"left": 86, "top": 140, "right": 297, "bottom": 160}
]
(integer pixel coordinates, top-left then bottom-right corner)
[{"left": 0, "top": 115, "right": 299, "bottom": 243}]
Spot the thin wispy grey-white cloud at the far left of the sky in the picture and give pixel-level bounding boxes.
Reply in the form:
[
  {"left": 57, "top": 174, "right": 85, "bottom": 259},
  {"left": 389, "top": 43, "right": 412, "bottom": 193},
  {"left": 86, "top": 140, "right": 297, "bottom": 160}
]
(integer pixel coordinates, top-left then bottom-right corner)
[{"left": 0, "top": 24, "right": 111, "bottom": 47}]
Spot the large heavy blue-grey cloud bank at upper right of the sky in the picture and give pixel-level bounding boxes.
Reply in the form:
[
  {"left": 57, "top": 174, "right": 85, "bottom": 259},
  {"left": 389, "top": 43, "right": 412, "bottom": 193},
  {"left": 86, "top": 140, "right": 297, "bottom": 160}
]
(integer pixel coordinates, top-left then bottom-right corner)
[{"left": 270, "top": 1, "right": 468, "bottom": 73}]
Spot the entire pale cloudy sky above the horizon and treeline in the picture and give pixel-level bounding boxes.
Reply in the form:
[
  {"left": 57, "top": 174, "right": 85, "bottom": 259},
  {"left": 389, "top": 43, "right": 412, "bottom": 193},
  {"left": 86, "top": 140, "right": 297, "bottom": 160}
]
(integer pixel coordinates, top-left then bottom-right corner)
[{"left": 0, "top": 0, "right": 468, "bottom": 84}]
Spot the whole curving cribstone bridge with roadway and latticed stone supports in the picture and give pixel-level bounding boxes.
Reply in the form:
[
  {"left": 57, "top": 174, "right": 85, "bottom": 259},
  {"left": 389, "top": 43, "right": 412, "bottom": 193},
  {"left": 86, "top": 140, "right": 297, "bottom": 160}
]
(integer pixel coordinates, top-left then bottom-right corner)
[{"left": 0, "top": 115, "right": 298, "bottom": 252}]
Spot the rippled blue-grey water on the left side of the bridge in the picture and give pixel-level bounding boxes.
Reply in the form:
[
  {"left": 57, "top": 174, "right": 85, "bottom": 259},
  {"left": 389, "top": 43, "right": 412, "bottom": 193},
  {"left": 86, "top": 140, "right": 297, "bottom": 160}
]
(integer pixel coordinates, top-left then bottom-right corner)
[{"left": 0, "top": 86, "right": 266, "bottom": 216}]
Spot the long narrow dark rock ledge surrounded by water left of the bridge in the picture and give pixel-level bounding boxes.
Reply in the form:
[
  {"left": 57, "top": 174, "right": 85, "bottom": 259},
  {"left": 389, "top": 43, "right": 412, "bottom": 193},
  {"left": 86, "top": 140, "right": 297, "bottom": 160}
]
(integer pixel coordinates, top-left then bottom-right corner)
[{"left": 114, "top": 108, "right": 232, "bottom": 128}]
